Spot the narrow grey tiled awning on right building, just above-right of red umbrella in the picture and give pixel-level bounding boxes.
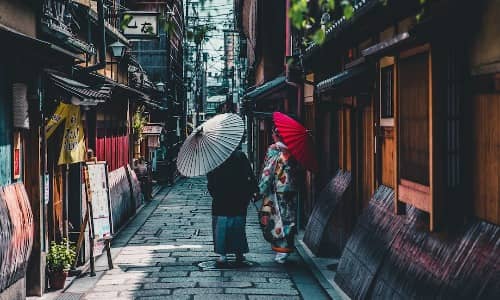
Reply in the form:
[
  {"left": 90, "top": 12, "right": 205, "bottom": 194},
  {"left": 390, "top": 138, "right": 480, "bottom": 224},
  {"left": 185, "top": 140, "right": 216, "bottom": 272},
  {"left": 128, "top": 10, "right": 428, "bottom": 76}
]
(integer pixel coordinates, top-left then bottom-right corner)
[{"left": 316, "top": 63, "right": 370, "bottom": 93}]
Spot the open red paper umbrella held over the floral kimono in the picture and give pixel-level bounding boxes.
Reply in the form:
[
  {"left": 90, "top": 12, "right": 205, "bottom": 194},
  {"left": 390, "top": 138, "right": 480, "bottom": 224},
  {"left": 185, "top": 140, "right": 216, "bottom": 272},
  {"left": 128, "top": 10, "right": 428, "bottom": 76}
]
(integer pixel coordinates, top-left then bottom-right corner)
[{"left": 273, "top": 112, "right": 318, "bottom": 172}]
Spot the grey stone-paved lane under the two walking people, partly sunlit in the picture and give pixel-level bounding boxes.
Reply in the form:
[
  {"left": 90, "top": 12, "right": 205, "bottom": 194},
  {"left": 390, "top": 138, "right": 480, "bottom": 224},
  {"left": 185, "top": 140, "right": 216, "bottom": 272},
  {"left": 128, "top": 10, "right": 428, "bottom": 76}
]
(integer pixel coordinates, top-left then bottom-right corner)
[{"left": 68, "top": 178, "right": 327, "bottom": 300}]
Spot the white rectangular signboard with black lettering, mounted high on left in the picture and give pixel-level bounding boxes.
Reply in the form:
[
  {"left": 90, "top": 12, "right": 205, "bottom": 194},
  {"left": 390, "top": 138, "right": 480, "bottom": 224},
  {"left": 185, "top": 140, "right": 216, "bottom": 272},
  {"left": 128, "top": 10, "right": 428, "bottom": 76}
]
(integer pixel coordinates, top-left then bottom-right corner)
[{"left": 123, "top": 11, "right": 159, "bottom": 39}]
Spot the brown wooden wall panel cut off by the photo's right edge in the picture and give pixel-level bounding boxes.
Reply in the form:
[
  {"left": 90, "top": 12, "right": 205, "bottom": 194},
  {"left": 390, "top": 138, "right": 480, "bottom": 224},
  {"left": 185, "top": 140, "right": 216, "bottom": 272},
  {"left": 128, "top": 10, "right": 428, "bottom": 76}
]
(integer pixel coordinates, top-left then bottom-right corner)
[{"left": 471, "top": 93, "right": 500, "bottom": 225}]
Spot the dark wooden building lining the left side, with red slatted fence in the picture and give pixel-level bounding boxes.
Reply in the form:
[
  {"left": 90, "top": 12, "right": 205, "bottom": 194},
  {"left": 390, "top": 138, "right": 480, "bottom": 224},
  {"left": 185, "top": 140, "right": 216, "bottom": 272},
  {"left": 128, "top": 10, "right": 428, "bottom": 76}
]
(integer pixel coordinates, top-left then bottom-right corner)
[{"left": 0, "top": 0, "right": 161, "bottom": 298}]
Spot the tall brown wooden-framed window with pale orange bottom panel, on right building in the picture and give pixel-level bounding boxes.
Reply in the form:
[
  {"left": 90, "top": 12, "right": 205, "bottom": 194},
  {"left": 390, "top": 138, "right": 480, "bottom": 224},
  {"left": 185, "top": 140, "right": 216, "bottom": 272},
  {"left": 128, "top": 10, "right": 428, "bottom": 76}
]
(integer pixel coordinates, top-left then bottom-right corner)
[{"left": 394, "top": 45, "right": 435, "bottom": 231}]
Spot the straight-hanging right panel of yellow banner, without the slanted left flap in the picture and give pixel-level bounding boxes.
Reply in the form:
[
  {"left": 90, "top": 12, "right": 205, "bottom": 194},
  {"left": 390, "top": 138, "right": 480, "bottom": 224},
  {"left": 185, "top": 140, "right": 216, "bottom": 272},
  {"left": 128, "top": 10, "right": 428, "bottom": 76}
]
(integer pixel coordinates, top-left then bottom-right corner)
[{"left": 58, "top": 104, "right": 86, "bottom": 165}]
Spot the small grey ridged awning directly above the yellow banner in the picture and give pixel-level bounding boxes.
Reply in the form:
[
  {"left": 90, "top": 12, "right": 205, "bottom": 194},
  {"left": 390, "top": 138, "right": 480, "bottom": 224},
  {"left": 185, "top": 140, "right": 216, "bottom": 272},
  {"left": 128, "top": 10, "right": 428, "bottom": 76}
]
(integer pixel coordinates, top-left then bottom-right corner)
[{"left": 48, "top": 72, "right": 111, "bottom": 106}]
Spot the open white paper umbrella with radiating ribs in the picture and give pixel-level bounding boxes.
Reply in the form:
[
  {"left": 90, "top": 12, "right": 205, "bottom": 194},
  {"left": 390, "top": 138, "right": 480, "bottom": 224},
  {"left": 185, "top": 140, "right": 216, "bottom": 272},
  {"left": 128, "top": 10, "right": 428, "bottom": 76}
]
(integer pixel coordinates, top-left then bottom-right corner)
[{"left": 177, "top": 113, "right": 244, "bottom": 177}]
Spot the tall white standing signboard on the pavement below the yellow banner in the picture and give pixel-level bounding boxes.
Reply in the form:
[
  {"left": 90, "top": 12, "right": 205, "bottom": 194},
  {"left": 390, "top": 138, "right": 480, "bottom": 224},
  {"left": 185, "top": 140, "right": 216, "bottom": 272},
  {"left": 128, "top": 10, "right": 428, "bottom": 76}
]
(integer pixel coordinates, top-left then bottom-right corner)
[{"left": 87, "top": 162, "right": 112, "bottom": 241}]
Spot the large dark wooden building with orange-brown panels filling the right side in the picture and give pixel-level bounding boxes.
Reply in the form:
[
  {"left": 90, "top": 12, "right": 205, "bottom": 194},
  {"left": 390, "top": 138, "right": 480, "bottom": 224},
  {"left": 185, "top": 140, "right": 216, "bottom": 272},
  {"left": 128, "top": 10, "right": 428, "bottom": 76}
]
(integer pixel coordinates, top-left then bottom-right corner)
[{"left": 240, "top": 0, "right": 500, "bottom": 299}]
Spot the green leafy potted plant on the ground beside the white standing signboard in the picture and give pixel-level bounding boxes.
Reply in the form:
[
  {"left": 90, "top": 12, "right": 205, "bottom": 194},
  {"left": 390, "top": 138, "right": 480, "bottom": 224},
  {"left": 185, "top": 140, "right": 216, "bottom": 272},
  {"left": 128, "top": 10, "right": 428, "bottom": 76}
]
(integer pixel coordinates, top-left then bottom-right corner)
[{"left": 47, "top": 239, "right": 76, "bottom": 290}]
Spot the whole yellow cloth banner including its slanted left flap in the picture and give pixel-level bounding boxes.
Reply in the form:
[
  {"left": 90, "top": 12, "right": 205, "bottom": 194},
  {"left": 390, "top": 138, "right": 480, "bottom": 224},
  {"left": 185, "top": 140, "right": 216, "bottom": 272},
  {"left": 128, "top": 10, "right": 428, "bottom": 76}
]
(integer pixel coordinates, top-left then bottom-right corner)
[{"left": 45, "top": 103, "right": 86, "bottom": 165}]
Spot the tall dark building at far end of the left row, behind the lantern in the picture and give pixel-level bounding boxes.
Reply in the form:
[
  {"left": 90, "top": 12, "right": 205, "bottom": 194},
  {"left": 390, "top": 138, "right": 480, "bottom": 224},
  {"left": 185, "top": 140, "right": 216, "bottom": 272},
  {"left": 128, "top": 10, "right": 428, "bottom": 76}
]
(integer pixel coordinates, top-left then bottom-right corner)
[{"left": 125, "top": 0, "right": 186, "bottom": 183}]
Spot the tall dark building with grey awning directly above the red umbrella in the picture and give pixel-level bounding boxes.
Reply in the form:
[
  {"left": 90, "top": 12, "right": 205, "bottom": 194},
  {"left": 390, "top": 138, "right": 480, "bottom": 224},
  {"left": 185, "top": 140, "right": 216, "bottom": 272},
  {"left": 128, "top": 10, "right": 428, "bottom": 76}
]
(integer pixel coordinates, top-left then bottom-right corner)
[{"left": 236, "top": 1, "right": 302, "bottom": 175}]
